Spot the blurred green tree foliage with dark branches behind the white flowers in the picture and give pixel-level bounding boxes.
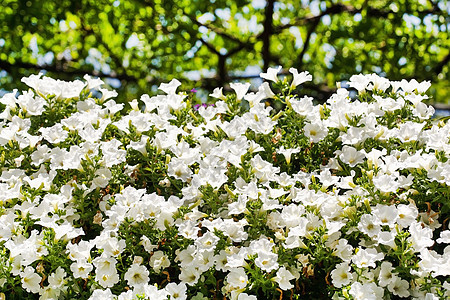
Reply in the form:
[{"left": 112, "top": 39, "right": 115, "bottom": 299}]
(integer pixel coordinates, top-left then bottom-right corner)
[{"left": 0, "top": 0, "right": 450, "bottom": 103}]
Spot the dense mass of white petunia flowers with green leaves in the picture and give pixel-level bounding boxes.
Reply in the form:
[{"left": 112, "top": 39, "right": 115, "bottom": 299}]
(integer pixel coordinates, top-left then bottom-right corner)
[{"left": 0, "top": 68, "right": 450, "bottom": 300}]
